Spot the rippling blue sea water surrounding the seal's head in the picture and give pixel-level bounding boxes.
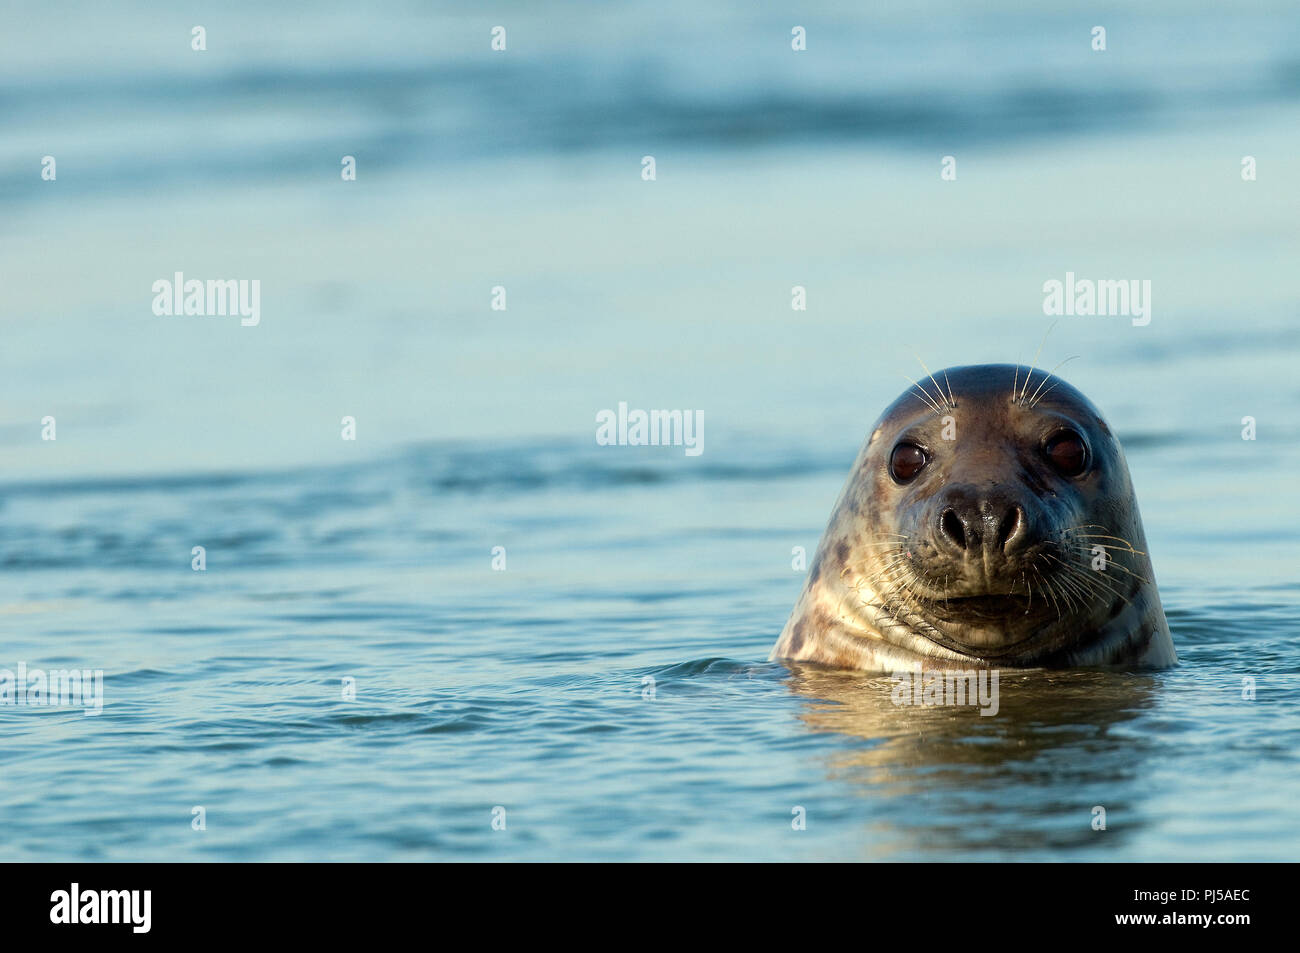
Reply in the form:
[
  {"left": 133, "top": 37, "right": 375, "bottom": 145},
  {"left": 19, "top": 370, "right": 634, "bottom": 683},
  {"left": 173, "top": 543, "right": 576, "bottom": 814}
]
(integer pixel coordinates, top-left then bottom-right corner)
[{"left": 0, "top": 3, "right": 1300, "bottom": 861}]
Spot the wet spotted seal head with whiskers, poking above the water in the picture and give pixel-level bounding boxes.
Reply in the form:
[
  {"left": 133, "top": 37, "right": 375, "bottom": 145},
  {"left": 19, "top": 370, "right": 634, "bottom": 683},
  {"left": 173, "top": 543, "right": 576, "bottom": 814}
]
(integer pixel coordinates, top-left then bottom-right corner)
[{"left": 772, "top": 364, "right": 1178, "bottom": 672}]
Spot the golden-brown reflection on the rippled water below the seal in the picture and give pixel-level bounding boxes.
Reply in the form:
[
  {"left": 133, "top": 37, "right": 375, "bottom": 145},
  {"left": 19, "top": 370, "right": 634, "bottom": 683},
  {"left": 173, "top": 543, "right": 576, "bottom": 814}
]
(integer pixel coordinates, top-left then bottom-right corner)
[{"left": 789, "top": 664, "right": 1162, "bottom": 859}]
